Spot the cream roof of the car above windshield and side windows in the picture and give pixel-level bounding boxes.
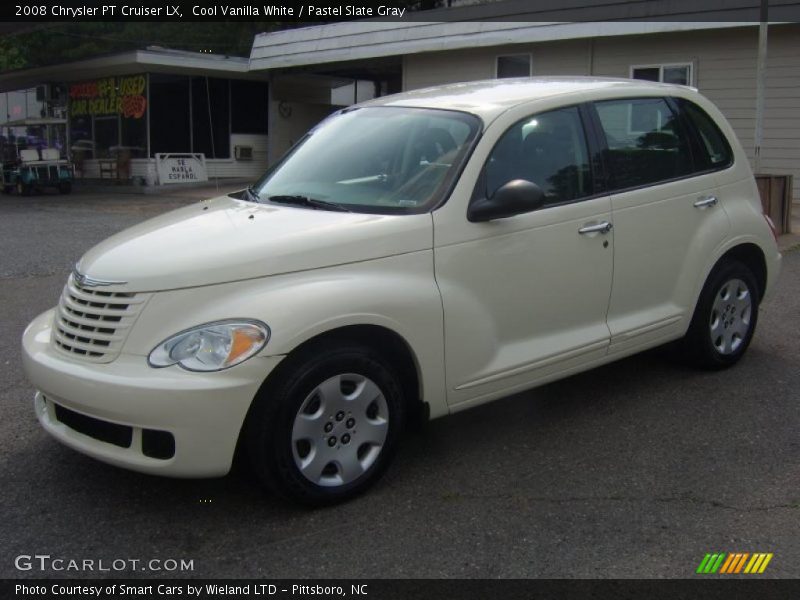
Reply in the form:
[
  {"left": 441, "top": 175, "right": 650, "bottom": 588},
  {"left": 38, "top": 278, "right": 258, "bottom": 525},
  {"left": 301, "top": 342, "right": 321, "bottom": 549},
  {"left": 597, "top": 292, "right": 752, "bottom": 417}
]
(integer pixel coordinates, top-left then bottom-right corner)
[{"left": 359, "top": 77, "right": 692, "bottom": 123}]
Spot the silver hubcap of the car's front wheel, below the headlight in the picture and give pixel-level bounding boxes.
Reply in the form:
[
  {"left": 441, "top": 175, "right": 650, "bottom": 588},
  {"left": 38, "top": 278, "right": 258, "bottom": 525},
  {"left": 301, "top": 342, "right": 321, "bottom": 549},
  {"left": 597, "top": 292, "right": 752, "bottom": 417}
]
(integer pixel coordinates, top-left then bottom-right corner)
[{"left": 292, "top": 373, "right": 389, "bottom": 487}]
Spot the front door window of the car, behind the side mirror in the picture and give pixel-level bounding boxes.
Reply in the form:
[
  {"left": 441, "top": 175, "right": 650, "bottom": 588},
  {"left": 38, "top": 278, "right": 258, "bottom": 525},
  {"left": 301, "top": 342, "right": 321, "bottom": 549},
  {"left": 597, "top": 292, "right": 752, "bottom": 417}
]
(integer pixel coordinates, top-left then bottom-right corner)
[{"left": 484, "top": 106, "right": 593, "bottom": 206}]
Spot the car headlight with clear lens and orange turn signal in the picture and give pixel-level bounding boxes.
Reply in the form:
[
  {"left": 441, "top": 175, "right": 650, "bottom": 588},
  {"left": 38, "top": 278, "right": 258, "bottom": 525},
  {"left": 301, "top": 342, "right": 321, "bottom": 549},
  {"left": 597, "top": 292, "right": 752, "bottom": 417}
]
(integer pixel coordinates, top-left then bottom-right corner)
[{"left": 147, "top": 319, "right": 269, "bottom": 371}]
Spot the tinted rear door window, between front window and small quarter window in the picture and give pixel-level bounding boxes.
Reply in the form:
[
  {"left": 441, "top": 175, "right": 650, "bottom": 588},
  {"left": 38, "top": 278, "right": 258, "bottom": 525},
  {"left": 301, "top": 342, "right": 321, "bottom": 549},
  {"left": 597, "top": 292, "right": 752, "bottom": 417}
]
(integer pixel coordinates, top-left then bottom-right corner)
[{"left": 595, "top": 98, "right": 693, "bottom": 189}]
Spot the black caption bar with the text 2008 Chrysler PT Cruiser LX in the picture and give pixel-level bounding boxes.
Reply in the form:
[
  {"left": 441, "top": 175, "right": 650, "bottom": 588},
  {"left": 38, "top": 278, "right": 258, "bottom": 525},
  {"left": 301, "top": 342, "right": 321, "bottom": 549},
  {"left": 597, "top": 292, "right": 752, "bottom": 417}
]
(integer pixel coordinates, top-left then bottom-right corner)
[{"left": 0, "top": 0, "right": 800, "bottom": 23}]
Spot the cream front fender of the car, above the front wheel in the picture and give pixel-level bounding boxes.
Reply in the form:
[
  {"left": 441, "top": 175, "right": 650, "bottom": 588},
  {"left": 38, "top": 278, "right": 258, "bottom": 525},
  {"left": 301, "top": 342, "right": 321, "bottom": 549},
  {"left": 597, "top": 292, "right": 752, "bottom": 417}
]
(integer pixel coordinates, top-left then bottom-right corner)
[{"left": 123, "top": 250, "right": 448, "bottom": 417}]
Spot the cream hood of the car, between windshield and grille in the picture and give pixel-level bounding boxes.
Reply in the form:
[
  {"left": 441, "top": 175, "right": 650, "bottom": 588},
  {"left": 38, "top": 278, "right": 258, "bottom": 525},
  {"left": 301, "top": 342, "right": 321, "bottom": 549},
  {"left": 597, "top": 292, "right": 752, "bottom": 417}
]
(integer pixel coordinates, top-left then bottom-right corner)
[{"left": 77, "top": 196, "right": 433, "bottom": 292}]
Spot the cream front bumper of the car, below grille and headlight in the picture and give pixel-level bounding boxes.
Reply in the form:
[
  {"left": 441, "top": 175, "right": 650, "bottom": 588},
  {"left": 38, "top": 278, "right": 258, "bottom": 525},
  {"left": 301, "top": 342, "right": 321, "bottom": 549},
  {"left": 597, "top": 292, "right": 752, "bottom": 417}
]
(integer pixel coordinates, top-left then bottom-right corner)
[{"left": 22, "top": 310, "right": 282, "bottom": 477}]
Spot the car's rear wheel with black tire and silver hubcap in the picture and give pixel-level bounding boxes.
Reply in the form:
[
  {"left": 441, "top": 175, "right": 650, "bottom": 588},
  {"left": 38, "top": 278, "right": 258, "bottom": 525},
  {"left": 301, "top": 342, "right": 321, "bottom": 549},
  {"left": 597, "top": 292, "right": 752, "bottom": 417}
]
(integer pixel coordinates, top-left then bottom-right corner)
[{"left": 677, "top": 259, "right": 761, "bottom": 369}]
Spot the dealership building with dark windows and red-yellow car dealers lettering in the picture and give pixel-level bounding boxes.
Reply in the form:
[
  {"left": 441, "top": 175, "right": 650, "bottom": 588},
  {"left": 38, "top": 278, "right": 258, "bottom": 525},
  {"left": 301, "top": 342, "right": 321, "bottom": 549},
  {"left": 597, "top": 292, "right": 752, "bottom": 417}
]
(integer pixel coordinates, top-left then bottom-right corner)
[{"left": 0, "top": 48, "right": 268, "bottom": 181}]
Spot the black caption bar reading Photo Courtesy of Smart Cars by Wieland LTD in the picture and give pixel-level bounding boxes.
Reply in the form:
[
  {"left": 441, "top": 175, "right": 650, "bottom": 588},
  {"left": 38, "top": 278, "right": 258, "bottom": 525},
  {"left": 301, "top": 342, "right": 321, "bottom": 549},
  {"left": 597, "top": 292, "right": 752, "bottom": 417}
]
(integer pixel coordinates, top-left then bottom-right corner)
[{"left": 0, "top": 576, "right": 800, "bottom": 600}]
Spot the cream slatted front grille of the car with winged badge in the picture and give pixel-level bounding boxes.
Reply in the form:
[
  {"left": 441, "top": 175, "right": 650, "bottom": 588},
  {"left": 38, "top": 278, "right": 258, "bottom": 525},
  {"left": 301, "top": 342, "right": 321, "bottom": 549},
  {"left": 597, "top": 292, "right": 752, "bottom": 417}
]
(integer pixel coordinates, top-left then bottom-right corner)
[{"left": 53, "top": 275, "right": 149, "bottom": 362}]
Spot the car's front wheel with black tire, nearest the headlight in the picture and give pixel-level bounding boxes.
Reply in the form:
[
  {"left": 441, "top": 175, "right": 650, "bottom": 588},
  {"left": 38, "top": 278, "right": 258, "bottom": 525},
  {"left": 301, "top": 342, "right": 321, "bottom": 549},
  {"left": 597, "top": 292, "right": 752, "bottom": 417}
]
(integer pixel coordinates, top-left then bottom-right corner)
[{"left": 244, "top": 340, "right": 406, "bottom": 506}]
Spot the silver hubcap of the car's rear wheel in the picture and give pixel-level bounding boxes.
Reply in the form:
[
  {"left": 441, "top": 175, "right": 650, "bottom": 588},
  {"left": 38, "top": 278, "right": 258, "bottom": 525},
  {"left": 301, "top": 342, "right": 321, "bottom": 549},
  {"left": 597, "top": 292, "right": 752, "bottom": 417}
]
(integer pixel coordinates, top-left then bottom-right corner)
[{"left": 709, "top": 279, "right": 753, "bottom": 354}]
